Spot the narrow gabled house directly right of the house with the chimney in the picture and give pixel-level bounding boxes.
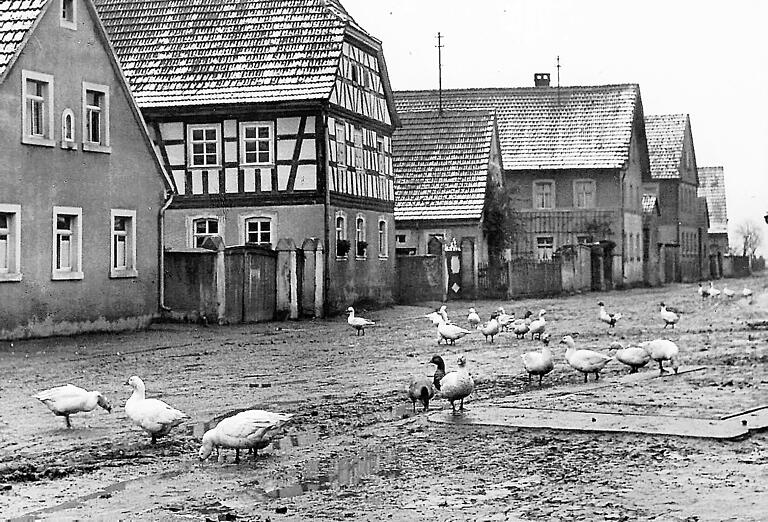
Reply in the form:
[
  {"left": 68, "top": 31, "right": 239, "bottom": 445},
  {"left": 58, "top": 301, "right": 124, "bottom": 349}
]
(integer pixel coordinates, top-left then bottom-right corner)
[{"left": 643, "top": 114, "right": 707, "bottom": 281}]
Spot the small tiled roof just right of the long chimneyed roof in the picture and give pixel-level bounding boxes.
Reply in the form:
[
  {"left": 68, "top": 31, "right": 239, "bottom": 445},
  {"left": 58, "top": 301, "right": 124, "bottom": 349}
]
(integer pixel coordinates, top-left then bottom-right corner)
[{"left": 645, "top": 114, "right": 688, "bottom": 179}]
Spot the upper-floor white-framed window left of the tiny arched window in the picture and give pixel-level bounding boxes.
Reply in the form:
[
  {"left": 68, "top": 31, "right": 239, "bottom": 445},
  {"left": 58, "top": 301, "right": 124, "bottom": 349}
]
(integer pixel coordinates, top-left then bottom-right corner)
[{"left": 21, "top": 70, "right": 54, "bottom": 147}]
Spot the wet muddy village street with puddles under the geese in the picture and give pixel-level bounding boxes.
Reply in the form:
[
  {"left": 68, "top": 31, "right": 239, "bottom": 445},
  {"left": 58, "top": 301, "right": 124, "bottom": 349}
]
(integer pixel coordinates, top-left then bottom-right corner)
[{"left": 0, "top": 277, "right": 768, "bottom": 521}]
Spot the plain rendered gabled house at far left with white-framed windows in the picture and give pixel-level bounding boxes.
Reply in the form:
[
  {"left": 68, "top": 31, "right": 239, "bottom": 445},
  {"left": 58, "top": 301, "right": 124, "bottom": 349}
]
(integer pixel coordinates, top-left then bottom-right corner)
[{"left": 0, "top": 0, "right": 170, "bottom": 339}]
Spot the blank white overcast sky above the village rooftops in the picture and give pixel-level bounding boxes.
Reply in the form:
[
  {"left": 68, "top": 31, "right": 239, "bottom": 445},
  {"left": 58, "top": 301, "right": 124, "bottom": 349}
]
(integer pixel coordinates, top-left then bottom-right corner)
[{"left": 342, "top": 0, "right": 768, "bottom": 252}]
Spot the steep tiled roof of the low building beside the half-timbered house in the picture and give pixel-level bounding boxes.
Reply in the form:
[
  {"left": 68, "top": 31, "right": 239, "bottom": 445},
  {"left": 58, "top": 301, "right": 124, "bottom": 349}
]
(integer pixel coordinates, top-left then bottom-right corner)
[{"left": 392, "top": 111, "right": 495, "bottom": 220}]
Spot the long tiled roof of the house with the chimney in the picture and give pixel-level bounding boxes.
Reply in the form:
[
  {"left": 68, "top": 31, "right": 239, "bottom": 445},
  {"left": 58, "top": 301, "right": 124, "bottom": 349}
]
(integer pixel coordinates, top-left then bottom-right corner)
[{"left": 395, "top": 84, "right": 641, "bottom": 170}]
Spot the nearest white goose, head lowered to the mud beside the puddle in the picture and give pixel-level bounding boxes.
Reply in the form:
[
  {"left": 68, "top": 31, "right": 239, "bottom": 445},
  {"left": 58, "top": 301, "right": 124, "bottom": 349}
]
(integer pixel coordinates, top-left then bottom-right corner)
[{"left": 199, "top": 410, "right": 293, "bottom": 462}]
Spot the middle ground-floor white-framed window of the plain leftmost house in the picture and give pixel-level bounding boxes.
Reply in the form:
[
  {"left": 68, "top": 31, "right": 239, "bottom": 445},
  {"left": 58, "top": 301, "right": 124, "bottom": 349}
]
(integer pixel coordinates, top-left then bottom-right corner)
[{"left": 51, "top": 207, "right": 83, "bottom": 280}]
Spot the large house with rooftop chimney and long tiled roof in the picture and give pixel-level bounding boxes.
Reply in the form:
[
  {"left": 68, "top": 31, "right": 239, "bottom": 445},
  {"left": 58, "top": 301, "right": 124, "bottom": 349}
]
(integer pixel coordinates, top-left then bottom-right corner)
[{"left": 395, "top": 79, "right": 649, "bottom": 287}]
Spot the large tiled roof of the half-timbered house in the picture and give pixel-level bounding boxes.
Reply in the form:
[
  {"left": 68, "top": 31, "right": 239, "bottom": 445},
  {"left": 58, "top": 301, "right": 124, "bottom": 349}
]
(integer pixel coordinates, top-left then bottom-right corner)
[{"left": 95, "top": 0, "right": 362, "bottom": 107}]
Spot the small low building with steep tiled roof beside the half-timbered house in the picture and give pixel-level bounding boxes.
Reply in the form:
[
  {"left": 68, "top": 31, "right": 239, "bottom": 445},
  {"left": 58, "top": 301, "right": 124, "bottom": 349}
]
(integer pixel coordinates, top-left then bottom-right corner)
[{"left": 393, "top": 111, "right": 503, "bottom": 297}]
